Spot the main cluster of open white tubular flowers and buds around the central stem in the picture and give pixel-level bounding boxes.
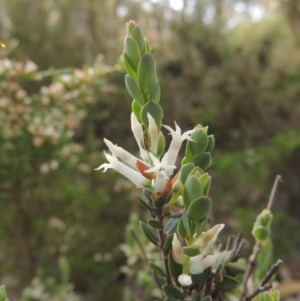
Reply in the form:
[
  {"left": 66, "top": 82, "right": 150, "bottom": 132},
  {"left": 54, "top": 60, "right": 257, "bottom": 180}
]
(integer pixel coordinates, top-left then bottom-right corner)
[{"left": 96, "top": 113, "right": 194, "bottom": 195}]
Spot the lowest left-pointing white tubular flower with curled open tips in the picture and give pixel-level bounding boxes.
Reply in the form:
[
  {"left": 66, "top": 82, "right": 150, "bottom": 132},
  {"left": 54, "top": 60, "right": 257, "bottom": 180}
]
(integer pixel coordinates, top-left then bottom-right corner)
[{"left": 95, "top": 152, "right": 151, "bottom": 188}]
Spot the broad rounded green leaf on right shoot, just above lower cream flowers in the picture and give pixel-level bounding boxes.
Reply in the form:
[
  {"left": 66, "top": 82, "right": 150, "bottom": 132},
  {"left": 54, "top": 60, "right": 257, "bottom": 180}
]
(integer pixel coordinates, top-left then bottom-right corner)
[{"left": 187, "top": 196, "right": 212, "bottom": 222}]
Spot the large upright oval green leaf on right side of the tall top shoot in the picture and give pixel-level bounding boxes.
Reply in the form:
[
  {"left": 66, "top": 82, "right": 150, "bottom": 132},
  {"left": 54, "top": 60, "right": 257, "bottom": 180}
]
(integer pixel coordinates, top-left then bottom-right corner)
[{"left": 137, "top": 52, "right": 156, "bottom": 91}]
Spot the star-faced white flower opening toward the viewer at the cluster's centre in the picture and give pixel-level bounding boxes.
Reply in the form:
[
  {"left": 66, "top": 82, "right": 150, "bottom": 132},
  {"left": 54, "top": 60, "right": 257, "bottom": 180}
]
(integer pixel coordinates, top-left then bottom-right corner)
[{"left": 145, "top": 153, "right": 176, "bottom": 193}]
